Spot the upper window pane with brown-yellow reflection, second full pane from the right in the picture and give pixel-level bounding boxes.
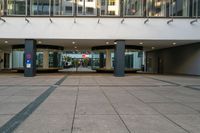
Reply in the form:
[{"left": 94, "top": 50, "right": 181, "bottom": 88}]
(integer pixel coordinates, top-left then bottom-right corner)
[{"left": 146, "top": 0, "right": 166, "bottom": 17}]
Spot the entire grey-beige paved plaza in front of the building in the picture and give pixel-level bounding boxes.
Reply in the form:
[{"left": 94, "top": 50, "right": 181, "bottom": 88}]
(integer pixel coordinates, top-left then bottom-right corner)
[{"left": 0, "top": 73, "right": 200, "bottom": 133}]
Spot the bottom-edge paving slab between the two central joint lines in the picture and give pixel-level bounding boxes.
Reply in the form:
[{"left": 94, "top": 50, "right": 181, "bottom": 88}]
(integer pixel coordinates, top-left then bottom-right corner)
[{"left": 73, "top": 115, "right": 128, "bottom": 133}]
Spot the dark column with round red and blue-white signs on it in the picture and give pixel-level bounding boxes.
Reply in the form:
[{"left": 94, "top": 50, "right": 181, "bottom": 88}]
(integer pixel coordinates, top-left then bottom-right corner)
[{"left": 24, "top": 39, "right": 36, "bottom": 77}]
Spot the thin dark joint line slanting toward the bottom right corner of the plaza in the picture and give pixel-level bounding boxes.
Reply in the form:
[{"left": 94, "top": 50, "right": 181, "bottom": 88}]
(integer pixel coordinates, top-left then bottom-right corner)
[{"left": 125, "top": 89, "right": 190, "bottom": 133}]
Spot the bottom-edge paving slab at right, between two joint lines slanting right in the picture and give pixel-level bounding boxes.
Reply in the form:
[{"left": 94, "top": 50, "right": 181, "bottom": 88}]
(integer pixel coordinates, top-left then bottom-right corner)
[{"left": 121, "top": 115, "right": 187, "bottom": 133}]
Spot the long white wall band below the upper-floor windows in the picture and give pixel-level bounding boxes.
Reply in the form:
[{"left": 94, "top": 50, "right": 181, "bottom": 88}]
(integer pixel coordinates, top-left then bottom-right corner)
[{"left": 0, "top": 17, "right": 200, "bottom": 40}]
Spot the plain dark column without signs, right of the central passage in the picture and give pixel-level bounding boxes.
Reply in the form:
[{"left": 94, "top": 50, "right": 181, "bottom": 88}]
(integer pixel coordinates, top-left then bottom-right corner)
[{"left": 114, "top": 40, "right": 125, "bottom": 77}]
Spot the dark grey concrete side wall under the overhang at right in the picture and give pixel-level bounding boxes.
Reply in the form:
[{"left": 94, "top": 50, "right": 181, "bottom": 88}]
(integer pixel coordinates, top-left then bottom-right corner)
[{"left": 146, "top": 43, "right": 200, "bottom": 75}]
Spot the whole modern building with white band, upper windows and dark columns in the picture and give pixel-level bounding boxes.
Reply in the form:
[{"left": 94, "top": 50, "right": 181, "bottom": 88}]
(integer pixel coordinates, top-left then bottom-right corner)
[{"left": 0, "top": 0, "right": 200, "bottom": 76}]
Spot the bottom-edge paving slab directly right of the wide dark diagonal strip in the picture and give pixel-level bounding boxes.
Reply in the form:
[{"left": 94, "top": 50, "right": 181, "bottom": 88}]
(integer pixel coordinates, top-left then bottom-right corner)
[{"left": 14, "top": 114, "right": 72, "bottom": 133}]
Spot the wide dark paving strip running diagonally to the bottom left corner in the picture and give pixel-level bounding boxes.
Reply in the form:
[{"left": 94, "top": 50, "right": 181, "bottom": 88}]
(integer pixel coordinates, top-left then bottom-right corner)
[{"left": 0, "top": 76, "right": 67, "bottom": 133}]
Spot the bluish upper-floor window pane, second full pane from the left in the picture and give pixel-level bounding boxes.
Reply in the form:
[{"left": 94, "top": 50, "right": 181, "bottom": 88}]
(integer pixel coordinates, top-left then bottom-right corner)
[{"left": 30, "top": 0, "right": 50, "bottom": 15}]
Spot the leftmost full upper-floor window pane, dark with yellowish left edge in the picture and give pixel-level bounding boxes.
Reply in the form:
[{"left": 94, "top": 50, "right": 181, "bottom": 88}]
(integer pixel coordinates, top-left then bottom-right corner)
[{"left": 7, "top": 0, "right": 26, "bottom": 15}]
